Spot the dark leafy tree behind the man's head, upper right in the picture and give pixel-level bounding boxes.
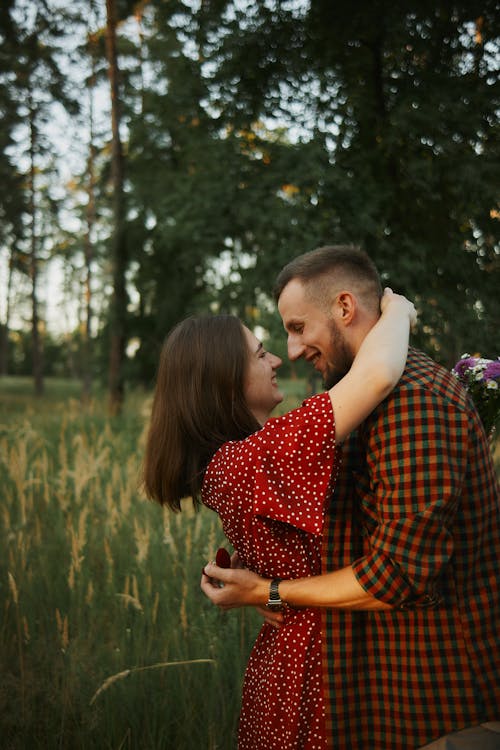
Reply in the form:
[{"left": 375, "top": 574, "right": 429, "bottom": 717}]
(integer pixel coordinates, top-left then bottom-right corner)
[{"left": 200, "top": 0, "right": 500, "bottom": 364}]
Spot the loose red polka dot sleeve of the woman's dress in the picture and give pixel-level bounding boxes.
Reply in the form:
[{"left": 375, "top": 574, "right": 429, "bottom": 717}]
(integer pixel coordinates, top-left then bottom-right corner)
[{"left": 205, "top": 394, "right": 337, "bottom": 534}]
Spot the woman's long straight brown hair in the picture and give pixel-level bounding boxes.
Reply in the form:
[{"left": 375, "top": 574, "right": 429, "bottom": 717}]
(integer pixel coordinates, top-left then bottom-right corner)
[{"left": 144, "top": 315, "right": 260, "bottom": 510}]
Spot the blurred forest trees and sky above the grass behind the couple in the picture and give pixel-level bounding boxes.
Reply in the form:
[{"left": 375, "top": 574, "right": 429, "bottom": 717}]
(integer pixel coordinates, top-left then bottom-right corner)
[{"left": 0, "top": 0, "right": 500, "bottom": 411}]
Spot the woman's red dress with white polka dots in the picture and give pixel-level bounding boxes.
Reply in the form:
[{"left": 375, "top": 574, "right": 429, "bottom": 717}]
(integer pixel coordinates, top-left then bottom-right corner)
[{"left": 203, "top": 394, "right": 338, "bottom": 750}]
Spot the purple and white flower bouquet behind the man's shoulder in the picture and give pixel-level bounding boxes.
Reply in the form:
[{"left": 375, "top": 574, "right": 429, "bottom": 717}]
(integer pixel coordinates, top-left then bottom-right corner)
[{"left": 452, "top": 354, "right": 500, "bottom": 437}]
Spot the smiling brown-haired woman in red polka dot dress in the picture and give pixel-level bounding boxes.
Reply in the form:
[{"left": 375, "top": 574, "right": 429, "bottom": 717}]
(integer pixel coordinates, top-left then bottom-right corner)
[{"left": 145, "top": 290, "right": 414, "bottom": 750}]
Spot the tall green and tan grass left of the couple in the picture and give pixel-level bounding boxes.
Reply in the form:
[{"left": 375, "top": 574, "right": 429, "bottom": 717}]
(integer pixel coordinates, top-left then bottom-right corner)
[{"left": 0, "top": 379, "right": 308, "bottom": 750}]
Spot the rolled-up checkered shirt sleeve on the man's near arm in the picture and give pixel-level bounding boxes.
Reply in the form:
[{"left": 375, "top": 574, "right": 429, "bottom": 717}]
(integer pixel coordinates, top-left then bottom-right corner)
[{"left": 352, "top": 388, "right": 469, "bottom": 608}]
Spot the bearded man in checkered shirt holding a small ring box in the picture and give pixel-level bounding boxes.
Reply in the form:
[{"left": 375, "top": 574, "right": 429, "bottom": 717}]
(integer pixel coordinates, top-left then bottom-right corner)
[{"left": 202, "top": 247, "right": 500, "bottom": 750}]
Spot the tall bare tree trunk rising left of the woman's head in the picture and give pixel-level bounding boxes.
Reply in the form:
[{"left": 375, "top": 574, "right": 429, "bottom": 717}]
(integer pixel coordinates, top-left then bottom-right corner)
[{"left": 106, "top": 0, "right": 127, "bottom": 414}]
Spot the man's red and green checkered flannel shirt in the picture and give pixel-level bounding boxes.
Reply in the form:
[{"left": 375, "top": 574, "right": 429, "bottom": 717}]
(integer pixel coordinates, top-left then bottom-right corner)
[{"left": 323, "top": 350, "right": 500, "bottom": 750}]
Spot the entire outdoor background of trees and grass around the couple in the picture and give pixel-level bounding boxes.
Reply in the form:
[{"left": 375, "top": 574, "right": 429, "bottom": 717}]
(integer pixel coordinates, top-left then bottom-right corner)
[{"left": 0, "top": 0, "right": 500, "bottom": 750}]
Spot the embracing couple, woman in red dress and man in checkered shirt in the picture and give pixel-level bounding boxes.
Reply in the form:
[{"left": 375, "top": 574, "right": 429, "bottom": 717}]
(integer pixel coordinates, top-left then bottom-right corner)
[{"left": 145, "top": 246, "right": 500, "bottom": 750}]
